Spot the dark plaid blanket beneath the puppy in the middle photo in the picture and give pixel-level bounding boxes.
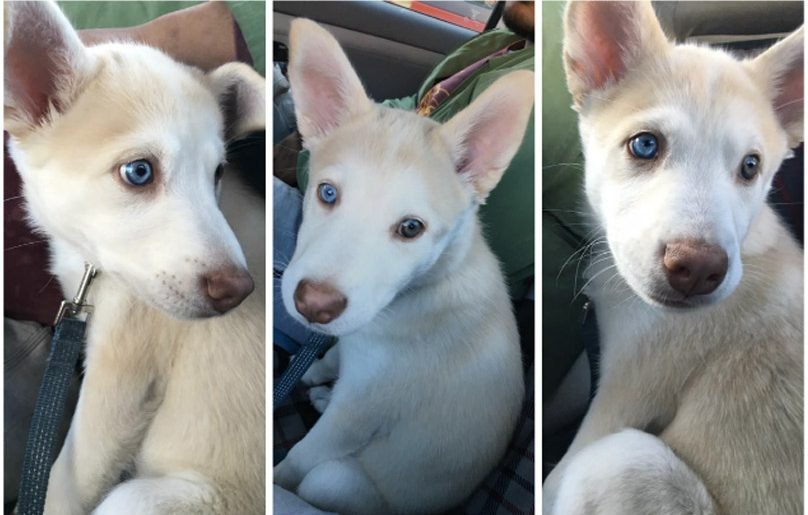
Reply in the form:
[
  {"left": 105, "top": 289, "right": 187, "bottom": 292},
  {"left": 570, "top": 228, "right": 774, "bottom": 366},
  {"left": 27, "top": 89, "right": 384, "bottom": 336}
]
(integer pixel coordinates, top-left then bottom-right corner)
[{"left": 273, "top": 348, "right": 535, "bottom": 515}]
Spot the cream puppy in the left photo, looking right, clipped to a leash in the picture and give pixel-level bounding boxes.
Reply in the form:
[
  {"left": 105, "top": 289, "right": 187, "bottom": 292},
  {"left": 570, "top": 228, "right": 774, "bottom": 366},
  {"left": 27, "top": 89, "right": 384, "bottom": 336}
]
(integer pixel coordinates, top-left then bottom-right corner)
[{"left": 4, "top": 2, "right": 265, "bottom": 515}]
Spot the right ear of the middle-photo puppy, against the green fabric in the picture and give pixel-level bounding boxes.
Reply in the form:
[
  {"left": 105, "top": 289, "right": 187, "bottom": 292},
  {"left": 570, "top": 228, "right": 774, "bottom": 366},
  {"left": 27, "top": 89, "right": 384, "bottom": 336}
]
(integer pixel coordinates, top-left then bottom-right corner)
[{"left": 439, "top": 70, "right": 533, "bottom": 204}]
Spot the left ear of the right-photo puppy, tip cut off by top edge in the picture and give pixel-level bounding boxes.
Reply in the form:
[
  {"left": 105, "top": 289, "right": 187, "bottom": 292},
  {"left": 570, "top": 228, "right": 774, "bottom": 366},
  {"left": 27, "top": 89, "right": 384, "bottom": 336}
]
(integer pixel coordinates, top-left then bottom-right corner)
[{"left": 564, "top": 0, "right": 671, "bottom": 108}]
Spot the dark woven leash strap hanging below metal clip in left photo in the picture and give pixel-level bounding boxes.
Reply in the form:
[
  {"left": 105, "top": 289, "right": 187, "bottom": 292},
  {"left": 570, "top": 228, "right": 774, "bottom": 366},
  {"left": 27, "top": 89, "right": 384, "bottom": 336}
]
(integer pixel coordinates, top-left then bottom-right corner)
[{"left": 17, "top": 317, "right": 86, "bottom": 515}]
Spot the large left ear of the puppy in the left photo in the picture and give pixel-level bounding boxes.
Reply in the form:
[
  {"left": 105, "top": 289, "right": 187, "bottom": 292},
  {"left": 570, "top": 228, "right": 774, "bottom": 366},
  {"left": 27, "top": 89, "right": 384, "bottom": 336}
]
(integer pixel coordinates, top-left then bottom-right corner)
[{"left": 3, "top": 1, "right": 93, "bottom": 135}]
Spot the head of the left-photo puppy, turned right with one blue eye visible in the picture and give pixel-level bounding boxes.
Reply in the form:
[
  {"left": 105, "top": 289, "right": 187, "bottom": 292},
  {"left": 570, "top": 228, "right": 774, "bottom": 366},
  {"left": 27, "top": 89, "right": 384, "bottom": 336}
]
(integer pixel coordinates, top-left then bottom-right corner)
[{"left": 4, "top": 2, "right": 264, "bottom": 317}]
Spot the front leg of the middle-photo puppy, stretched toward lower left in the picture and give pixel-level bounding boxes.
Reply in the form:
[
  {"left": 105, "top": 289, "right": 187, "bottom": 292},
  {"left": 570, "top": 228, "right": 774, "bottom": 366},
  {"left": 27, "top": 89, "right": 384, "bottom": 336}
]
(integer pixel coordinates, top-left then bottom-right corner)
[{"left": 273, "top": 400, "right": 379, "bottom": 492}]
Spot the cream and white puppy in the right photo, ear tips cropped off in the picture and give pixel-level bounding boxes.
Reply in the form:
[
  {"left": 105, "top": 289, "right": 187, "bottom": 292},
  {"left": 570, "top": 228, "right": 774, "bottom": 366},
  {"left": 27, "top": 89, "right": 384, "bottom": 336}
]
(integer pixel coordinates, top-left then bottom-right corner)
[{"left": 544, "top": 2, "right": 803, "bottom": 515}]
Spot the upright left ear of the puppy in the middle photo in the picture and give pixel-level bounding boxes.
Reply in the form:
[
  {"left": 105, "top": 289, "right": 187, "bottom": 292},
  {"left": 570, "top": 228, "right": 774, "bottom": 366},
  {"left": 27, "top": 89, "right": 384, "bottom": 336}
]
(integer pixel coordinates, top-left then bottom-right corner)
[{"left": 289, "top": 19, "right": 373, "bottom": 148}]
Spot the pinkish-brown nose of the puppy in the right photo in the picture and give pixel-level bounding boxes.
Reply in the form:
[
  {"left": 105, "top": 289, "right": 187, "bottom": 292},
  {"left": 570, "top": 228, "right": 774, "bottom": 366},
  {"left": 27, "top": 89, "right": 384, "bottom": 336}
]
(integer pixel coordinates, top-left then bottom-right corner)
[{"left": 662, "top": 240, "right": 729, "bottom": 297}]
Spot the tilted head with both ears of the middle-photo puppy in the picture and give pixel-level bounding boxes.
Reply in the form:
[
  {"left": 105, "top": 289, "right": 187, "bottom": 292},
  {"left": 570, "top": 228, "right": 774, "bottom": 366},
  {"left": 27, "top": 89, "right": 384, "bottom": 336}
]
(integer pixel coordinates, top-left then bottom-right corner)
[{"left": 282, "top": 20, "right": 533, "bottom": 335}]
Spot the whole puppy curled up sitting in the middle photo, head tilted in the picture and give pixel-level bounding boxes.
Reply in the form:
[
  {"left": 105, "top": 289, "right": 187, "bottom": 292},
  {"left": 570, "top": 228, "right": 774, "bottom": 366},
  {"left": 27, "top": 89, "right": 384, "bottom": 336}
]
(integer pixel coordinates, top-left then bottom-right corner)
[{"left": 274, "top": 20, "right": 533, "bottom": 514}]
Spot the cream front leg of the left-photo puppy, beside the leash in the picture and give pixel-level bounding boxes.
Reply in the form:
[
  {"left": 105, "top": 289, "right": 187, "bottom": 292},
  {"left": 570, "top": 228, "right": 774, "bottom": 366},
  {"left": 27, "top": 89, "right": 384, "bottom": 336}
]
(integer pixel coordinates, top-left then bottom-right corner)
[{"left": 45, "top": 348, "right": 159, "bottom": 515}]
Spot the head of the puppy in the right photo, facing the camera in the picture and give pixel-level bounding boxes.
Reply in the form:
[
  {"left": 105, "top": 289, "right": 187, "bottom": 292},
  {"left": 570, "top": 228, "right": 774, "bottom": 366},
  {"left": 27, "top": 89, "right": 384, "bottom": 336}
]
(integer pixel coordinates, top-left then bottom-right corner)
[{"left": 564, "top": 2, "right": 803, "bottom": 307}]
